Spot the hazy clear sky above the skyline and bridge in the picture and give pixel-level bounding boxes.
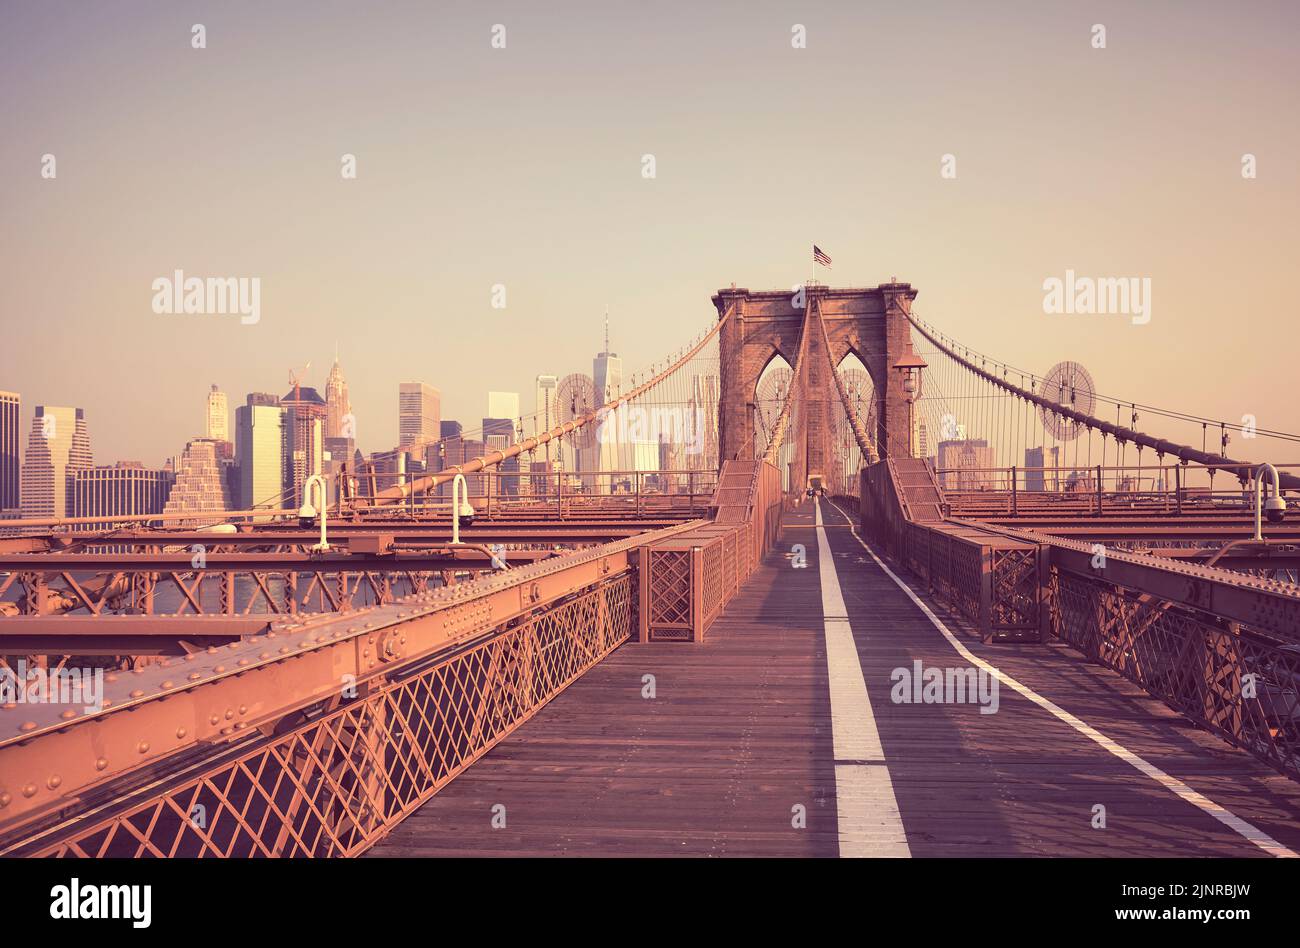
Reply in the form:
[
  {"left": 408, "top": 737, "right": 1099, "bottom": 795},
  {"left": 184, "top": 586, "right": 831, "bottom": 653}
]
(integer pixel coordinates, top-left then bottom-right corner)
[{"left": 0, "top": 0, "right": 1300, "bottom": 464}]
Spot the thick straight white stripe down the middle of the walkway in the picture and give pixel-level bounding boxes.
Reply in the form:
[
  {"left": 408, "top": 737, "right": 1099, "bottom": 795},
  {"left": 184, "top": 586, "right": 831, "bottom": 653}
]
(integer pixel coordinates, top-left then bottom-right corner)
[{"left": 816, "top": 502, "right": 911, "bottom": 858}]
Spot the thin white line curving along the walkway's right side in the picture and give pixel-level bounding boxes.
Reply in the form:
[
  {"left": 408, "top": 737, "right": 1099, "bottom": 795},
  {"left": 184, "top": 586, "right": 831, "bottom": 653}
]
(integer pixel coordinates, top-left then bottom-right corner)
[{"left": 818, "top": 501, "right": 1297, "bottom": 858}]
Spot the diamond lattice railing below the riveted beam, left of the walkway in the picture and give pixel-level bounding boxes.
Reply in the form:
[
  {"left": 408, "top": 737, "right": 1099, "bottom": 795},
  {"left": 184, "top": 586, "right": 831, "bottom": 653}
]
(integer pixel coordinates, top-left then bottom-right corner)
[{"left": 9, "top": 573, "right": 633, "bottom": 857}]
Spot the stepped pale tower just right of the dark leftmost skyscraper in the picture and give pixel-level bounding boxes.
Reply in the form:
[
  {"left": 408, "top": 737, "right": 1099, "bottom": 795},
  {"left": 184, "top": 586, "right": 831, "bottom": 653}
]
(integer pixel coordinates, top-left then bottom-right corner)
[{"left": 21, "top": 404, "right": 94, "bottom": 519}]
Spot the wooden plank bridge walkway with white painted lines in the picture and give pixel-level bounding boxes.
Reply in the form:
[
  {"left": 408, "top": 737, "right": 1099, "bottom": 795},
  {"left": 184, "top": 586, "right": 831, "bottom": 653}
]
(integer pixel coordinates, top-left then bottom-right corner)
[{"left": 371, "top": 502, "right": 1300, "bottom": 857}]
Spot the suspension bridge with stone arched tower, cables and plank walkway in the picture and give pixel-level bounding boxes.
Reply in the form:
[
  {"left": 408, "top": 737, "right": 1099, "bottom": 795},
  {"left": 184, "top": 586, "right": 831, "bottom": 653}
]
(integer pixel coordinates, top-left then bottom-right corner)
[{"left": 0, "top": 281, "right": 1300, "bottom": 857}]
